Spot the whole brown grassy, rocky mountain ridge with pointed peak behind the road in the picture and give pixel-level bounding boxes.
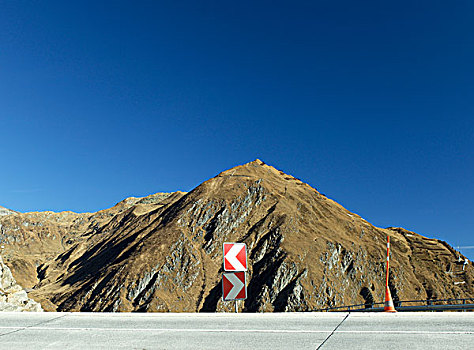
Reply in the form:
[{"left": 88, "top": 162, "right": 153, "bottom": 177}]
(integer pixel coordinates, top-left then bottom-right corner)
[{"left": 0, "top": 160, "right": 474, "bottom": 312}]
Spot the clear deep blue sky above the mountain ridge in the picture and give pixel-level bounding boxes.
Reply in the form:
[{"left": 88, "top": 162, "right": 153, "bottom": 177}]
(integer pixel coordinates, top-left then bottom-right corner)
[{"left": 0, "top": 1, "right": 474, "bottom": 258}]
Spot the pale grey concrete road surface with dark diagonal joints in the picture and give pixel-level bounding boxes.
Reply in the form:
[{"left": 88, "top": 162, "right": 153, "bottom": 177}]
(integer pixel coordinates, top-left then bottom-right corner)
[{"left": 0, "top": 312, "right": 474, "bottom": 350}]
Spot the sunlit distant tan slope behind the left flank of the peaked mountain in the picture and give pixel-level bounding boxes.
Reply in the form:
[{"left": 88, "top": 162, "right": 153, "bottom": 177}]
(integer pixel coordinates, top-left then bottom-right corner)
[{"left": 0, "top": 193, "right": 181, "bottom": 289}]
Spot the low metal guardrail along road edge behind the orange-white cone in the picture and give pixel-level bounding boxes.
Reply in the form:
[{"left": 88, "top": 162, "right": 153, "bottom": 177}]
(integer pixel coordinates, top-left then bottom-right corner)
[{"left": 314, "top": 298, "right": 474, "bottom": 312}]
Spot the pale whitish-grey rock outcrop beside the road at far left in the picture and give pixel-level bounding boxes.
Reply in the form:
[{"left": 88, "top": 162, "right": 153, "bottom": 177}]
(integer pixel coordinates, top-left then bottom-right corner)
[{"left": 0, "top": 257, "right": 43, "bottom": 312}]
